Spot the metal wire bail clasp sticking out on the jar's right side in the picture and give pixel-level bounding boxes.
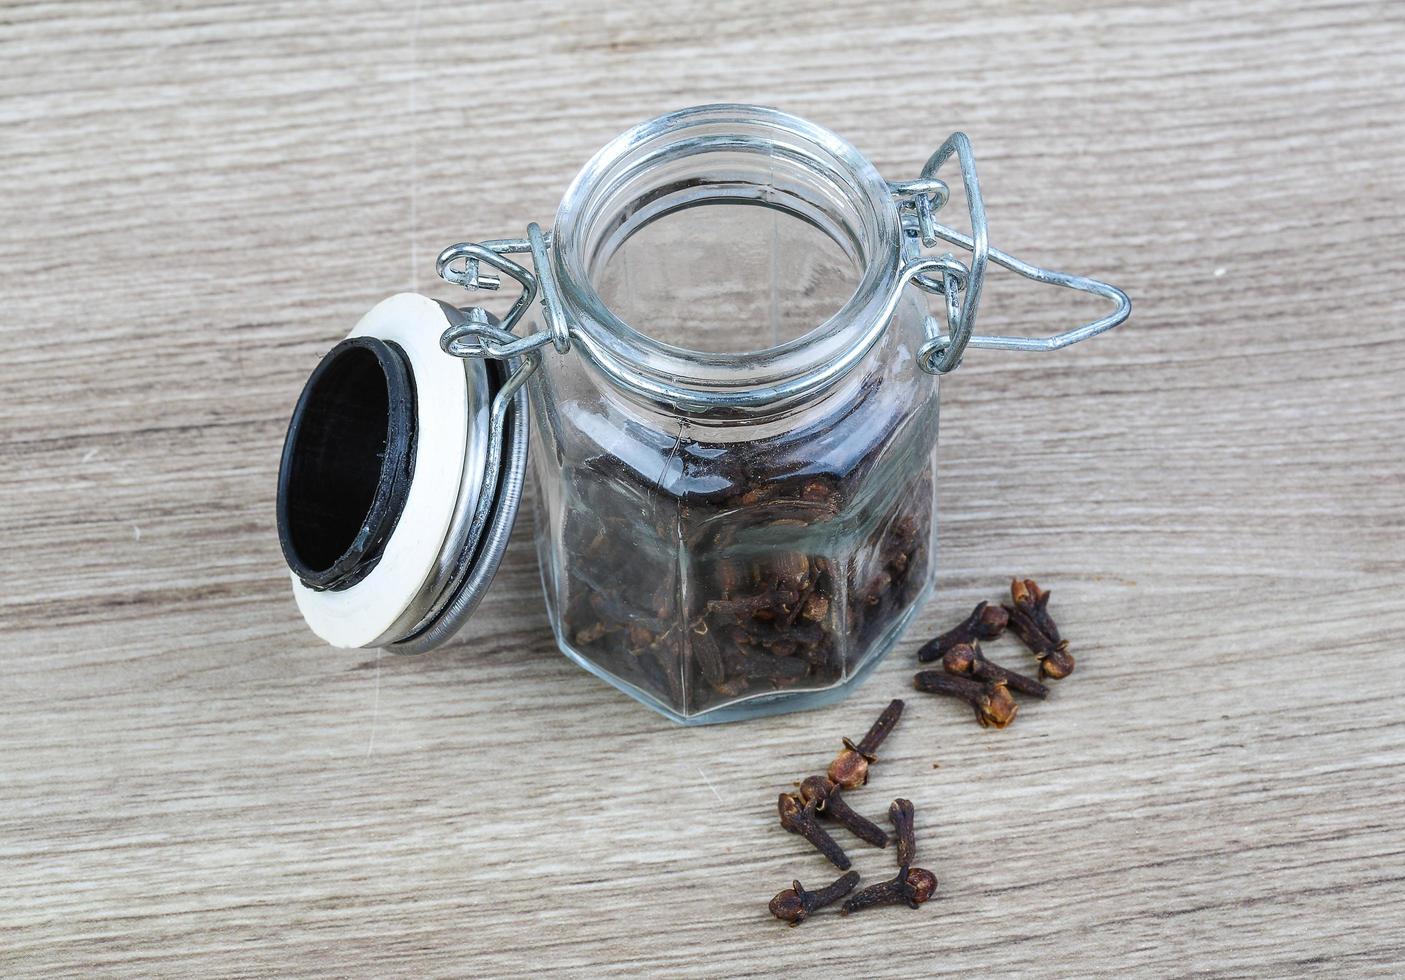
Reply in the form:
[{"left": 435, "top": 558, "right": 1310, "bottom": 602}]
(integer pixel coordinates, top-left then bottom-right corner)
[{"left": 888, "top": 132, "right": 1132, "bottom": 375}]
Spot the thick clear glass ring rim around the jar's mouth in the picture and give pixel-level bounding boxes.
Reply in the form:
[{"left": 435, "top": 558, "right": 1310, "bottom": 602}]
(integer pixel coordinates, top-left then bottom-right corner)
[{"left": 552, "top": 104, "right": 902, "bottom": 414}]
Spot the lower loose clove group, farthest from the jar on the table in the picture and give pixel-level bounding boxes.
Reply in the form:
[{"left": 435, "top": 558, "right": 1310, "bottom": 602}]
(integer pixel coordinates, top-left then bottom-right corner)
[{"left": 770, "top": 699, "right": 937, "bottom": 925}]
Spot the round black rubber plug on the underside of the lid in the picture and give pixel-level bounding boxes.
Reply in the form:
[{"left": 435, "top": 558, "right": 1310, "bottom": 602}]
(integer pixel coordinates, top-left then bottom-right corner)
[{"left": 277, "top": 337, "right": 416, "bottom": 591}]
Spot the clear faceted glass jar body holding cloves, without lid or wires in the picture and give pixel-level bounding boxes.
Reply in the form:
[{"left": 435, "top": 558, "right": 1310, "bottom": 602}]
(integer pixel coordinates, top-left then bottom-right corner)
[{"left": 531, "top": 107, "right": 937, "bottom": 723}]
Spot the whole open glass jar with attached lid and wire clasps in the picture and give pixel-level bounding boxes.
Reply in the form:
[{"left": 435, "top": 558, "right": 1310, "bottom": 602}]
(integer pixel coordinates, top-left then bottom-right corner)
[{"left": 280, "top": 105, "right": 1130, "bottom": 723}]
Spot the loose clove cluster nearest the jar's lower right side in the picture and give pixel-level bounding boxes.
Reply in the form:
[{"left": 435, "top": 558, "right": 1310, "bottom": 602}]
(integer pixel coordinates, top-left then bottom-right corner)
[{"left": 912, "top": 578, "right": 1073, "bottom": 729}]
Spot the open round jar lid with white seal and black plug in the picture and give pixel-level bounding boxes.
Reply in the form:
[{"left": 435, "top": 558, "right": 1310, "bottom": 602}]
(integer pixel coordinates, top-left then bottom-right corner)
[{"left": 278, "top": 293, "right": 527, "bottom": 651}]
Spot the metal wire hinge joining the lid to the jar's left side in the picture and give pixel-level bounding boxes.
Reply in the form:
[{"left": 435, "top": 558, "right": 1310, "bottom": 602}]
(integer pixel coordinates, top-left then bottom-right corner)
[{"left": 434, "top": 222, "right": 570, "bottom": 362}]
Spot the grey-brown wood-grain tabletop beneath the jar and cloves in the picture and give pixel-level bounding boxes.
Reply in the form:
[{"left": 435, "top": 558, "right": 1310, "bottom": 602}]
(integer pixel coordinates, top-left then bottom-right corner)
[{"left": 0, "top": 0, "right": 1405, "bottom": 976}]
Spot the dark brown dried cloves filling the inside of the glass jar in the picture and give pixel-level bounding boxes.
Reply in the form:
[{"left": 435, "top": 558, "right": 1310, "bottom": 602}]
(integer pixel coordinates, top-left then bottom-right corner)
[{"left": 548, "top": 444, "right": 932, "bottom": 715}]
